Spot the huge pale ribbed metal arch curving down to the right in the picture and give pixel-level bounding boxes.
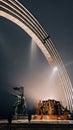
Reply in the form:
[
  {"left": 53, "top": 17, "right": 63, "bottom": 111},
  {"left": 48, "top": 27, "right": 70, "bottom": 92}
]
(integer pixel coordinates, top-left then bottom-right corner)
[{"left": 0, "top": 0, "right": 73, "bottom": 111}]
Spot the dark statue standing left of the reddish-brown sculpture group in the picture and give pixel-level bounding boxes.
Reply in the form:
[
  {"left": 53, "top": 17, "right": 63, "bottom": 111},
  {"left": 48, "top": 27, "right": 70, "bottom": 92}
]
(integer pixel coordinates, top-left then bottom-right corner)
[{"left": 13, "top": 86, "right": 27, "bottom": 117}]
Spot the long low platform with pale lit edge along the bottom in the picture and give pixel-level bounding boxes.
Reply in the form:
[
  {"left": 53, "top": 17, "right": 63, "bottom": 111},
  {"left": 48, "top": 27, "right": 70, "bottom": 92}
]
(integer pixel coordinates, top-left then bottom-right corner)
[{"left": 0, "top": 120, "right": 73, "bottom": 130}]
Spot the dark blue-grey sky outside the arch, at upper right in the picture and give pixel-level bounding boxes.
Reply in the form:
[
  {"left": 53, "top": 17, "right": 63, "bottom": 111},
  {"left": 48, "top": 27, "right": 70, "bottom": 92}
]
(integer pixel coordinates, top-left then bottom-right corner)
[{"left": 19, "top": 0, "right": 73, "bottom": 84}]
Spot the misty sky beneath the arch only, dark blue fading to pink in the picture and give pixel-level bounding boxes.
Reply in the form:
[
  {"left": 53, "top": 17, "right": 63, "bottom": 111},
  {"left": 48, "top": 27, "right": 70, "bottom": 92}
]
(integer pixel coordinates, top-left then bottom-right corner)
[{"left": 0, "top": 18, "right": 59, "bottom": 116}]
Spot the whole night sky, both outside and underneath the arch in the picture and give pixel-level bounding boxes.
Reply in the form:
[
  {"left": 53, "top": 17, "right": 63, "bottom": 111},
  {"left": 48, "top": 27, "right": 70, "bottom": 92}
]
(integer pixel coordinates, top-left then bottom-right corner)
[{"left": 0, "top": 0, "right": 73, "bottom": 115}]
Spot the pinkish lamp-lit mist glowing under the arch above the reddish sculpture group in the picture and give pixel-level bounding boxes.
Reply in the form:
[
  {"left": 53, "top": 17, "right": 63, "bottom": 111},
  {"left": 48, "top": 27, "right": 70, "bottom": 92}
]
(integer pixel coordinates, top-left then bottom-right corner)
[{"left": 25, "top": 39, "right": 59, "bottom": 101}]
